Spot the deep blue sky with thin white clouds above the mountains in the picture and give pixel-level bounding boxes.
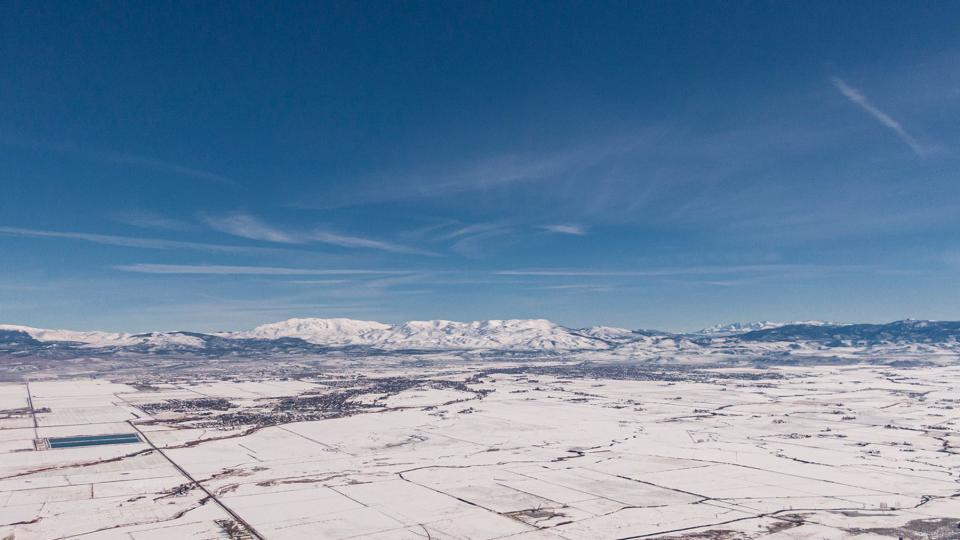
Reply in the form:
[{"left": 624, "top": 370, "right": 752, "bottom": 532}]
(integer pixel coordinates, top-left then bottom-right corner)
[{"left": 0, "top": 1, "right": 960, "bottom": 331}]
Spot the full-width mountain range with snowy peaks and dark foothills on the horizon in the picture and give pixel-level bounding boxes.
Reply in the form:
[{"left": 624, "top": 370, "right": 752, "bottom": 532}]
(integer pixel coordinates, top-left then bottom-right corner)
[{"left": 0, "top": 318, "right": 960, "bottom": 359}]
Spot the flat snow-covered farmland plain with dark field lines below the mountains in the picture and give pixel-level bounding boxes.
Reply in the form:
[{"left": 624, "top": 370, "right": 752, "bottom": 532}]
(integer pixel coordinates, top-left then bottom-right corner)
[{"left": 0, "top": 359, "right": 960, "bottom": 540}]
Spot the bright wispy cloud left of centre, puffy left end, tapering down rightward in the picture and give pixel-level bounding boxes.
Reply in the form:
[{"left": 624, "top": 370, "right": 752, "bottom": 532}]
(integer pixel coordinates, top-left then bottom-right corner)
[{"left": 205, "top": 213, "right": 438, "bottom": 256}]
